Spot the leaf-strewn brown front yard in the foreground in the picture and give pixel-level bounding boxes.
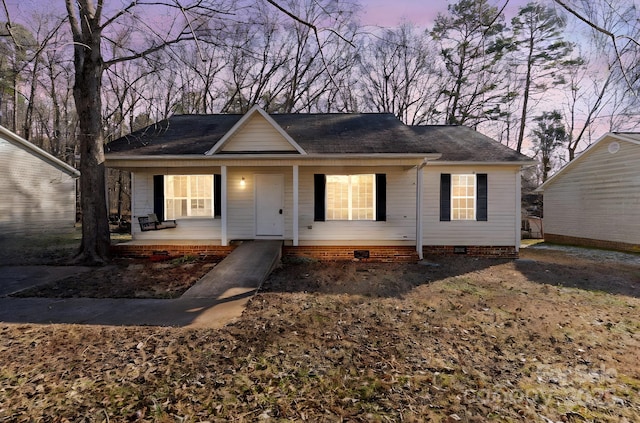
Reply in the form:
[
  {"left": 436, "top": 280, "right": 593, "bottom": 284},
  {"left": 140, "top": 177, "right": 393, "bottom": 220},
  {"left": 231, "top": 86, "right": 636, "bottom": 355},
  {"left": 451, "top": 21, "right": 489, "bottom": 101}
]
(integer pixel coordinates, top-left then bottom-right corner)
[{"left": 0, "top": 246, "right": 640, "bottom": 423}]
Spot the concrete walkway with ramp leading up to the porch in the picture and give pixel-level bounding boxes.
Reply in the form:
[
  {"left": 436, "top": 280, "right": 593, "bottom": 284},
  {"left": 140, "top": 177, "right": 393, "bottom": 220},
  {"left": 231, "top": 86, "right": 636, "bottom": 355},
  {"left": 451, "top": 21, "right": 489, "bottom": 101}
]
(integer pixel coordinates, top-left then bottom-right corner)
[{"left": 0, "top": 241, "right": 282, "bottom": 328}]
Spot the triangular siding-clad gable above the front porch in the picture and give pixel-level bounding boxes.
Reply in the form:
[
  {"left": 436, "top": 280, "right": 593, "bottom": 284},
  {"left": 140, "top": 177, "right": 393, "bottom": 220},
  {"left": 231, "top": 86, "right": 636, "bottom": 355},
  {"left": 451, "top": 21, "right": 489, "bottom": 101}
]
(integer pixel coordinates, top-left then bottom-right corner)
[{"left": 222, "top": 113, "right": 296, "bottom": 153}]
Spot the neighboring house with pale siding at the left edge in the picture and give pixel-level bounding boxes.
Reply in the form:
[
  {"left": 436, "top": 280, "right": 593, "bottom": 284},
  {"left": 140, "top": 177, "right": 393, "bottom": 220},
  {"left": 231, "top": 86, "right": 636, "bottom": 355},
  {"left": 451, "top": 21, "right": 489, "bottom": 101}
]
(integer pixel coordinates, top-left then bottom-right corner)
[{"left": 0, "top": 126, "right": 80, "bottom": 239}]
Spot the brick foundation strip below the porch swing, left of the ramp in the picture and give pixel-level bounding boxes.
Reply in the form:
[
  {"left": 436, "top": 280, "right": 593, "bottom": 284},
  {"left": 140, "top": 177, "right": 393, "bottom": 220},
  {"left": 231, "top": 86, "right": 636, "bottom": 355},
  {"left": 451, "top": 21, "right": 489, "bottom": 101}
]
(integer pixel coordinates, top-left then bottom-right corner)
[{"left": 111, "top": 243, "right": 236, "bottom": 258}]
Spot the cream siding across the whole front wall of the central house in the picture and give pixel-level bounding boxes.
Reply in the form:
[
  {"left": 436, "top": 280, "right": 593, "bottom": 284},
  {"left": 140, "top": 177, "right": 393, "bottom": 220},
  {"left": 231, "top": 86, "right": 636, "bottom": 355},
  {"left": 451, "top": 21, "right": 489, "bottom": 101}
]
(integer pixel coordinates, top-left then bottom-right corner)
[{"left": 132, "top": 165, "right": 520, "bottom": 246}]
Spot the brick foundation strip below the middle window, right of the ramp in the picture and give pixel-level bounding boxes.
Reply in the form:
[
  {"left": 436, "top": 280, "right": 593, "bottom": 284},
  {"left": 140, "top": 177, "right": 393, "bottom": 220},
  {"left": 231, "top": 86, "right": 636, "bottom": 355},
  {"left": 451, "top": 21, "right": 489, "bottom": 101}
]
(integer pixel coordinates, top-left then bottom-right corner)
[{"left": 282, "top": 245, "right": 418, "bottom": 263}]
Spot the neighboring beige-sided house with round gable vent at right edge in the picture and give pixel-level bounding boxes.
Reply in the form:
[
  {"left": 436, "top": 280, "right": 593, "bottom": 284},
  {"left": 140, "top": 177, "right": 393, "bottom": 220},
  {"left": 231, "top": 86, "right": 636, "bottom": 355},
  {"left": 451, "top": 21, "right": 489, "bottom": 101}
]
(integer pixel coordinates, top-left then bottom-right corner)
[{"left": 538, "top": 132, "right": 640, "bottom": 252}]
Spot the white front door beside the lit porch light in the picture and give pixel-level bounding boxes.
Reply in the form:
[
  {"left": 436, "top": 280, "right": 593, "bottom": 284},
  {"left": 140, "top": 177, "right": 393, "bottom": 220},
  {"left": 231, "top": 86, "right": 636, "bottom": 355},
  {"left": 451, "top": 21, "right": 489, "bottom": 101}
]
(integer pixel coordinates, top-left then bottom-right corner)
[{"left": 255, "top": 174, "right": 284, "bottom": 237}]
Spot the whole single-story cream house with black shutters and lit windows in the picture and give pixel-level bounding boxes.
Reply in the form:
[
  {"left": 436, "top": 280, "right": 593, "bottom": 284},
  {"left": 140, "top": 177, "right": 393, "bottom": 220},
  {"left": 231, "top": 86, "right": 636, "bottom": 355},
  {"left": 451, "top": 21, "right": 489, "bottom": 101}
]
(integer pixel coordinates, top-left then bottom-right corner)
[{"left": 106, "top": 107, "right": 533, "bottom": 259}]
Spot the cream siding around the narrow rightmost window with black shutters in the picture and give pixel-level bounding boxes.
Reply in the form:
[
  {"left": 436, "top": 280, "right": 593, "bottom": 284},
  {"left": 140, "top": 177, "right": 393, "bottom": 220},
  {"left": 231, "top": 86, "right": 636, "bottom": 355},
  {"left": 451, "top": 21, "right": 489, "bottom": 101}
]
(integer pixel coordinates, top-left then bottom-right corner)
[{"left": 422, "top": 165, "right": 520, "bottom": 246}]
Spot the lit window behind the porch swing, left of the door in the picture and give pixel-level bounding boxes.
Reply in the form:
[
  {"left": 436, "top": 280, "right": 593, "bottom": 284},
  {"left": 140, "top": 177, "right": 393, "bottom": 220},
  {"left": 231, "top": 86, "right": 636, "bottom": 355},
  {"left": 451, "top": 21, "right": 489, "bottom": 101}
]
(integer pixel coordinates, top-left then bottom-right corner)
[{"left": 164, "top": 175, "right": 214, "bottom": 219}]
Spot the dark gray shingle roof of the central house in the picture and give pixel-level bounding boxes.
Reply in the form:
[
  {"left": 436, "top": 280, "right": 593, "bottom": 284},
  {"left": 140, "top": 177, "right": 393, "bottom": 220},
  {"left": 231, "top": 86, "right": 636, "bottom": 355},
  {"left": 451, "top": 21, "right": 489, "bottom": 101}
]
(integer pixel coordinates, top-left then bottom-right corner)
[{"left": 105, "top": 113, "right": 529, "bottom": 161}]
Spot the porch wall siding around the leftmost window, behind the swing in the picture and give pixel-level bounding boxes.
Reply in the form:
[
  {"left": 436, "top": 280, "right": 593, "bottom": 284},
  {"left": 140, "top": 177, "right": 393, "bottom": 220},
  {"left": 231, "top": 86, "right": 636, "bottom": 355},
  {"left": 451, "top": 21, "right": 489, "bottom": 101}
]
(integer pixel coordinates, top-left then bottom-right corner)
[{"left": 131, "top": 168, "right": 221, "bottom": 242}]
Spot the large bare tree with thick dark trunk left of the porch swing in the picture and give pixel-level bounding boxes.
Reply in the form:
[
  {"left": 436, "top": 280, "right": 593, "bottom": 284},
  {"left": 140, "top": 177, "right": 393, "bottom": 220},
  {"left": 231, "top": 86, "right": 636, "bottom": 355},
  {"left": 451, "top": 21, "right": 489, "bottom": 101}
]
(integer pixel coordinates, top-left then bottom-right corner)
[{"left": 65, "top": 0, "right": 236, "bottom": 264}]
